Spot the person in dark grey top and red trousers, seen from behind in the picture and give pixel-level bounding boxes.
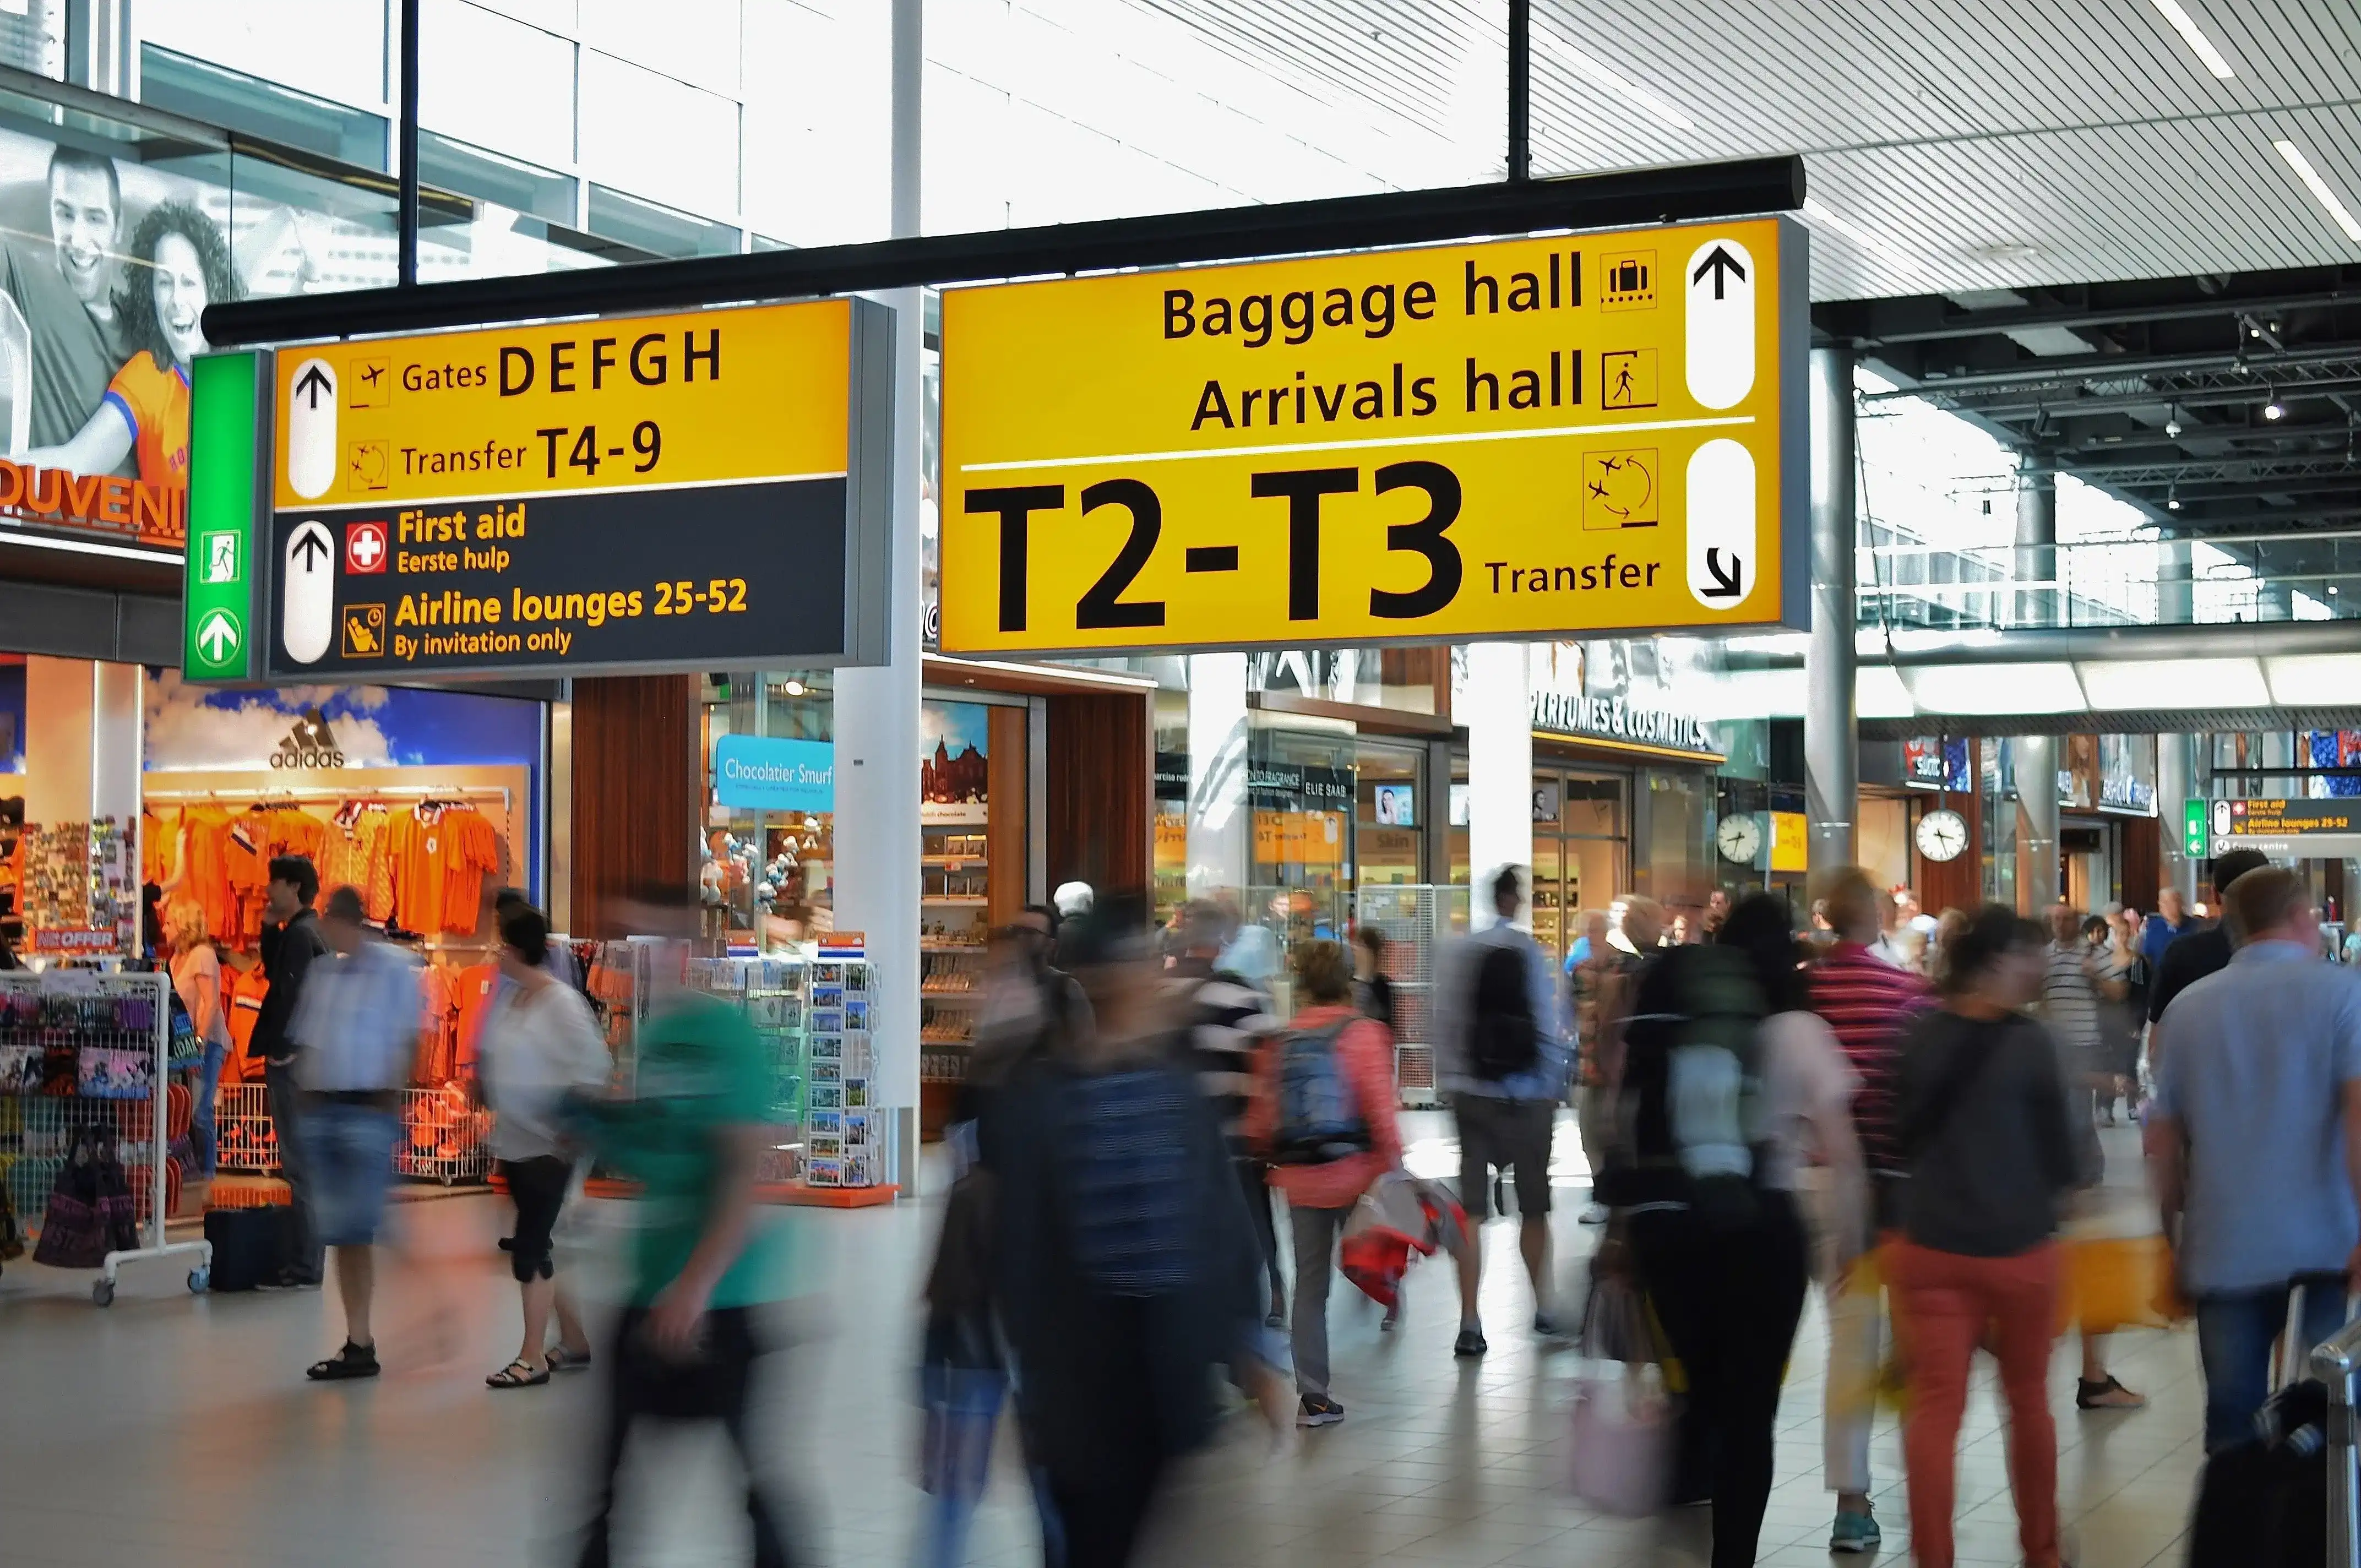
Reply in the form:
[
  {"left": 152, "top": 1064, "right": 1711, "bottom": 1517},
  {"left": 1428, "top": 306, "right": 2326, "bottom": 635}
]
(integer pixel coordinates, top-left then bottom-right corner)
[{"left": 1889, "top": 905, "right": 2080, "bottom": 1568}]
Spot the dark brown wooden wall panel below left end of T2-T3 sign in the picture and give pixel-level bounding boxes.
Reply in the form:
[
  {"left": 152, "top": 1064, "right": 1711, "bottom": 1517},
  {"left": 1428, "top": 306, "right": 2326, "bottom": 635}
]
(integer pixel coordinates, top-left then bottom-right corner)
[{"left": 1048, "top": 692, "right": 1155, "bottom": 900}]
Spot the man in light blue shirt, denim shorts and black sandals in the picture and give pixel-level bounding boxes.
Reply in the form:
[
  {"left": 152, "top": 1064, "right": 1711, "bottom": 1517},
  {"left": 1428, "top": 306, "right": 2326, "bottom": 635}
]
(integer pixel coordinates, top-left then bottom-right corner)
[{"left": 289, "top": 888, "right": 420, "bottom": 1381}]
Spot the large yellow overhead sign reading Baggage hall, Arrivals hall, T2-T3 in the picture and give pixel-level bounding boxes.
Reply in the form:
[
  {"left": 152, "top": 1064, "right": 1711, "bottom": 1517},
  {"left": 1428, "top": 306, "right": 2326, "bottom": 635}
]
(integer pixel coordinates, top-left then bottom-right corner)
[{"left": 942, "top": 217, "right": 1809, "bottom": 654}]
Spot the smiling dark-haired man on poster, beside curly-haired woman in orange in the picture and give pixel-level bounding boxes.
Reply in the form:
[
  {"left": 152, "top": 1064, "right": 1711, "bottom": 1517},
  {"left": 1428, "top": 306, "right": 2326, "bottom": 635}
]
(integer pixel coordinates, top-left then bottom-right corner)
[{"left": 0, "top": 146, "right": 132, "bottom": 462}]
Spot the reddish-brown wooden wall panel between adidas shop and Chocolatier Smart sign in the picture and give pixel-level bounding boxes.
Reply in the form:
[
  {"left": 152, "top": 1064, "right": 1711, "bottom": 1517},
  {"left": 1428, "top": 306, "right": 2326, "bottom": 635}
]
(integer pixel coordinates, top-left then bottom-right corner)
[{"left": 572, "top": 676, "right": 704, "bottom": 938}]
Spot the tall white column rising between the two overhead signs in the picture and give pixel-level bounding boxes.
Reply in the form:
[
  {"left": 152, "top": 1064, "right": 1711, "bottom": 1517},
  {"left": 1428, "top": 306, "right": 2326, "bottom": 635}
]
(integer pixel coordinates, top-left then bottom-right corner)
[{"left": 836, "top": 0, "right": 921, "bottom": 1197}]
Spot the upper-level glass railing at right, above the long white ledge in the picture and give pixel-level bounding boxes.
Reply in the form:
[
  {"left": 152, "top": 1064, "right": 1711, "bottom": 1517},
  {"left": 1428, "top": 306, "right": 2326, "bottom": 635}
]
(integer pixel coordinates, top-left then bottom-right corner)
[{"left": 1856, "top": 531, "right": 2361, "bottom": 630}]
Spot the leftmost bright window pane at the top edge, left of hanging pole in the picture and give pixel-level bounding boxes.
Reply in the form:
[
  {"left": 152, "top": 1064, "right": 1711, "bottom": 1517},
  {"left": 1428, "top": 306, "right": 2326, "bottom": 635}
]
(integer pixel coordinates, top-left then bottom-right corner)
[{"left": 138, "top": 0, "right": 392, "bottom": 123}]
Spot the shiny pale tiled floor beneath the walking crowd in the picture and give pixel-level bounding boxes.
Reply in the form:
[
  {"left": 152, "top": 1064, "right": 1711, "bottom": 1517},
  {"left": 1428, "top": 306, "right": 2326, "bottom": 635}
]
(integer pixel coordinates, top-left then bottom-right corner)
[{"left": 0, "top": 1119, "right": 2200, "bottom": 1568}]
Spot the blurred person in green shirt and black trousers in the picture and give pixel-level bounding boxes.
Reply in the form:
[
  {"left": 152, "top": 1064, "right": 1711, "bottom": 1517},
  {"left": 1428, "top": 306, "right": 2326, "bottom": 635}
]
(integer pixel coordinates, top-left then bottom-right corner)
[{"left": 569, "top": 902, "right": 791, "bottom": 1568}]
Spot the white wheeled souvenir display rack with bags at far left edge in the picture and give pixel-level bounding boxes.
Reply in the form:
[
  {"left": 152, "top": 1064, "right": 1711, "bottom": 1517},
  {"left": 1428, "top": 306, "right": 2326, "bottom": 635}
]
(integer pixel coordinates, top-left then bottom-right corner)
[{"left": 0, "top": 971, "right": 213, "bottom": 1306}]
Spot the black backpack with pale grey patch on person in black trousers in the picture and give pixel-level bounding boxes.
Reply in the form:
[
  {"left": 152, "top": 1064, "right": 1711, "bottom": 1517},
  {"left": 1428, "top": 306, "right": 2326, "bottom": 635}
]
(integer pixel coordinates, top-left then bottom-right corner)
[{"left": 1606, "top": 947, "right": 1769, "bottom": 1226}]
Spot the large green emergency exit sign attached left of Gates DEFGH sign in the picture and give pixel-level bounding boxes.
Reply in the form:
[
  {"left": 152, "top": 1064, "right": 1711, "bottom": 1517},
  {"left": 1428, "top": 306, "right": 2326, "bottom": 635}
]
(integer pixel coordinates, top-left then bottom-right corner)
[{"left": 179, "top": 354, "right": 264, "bottom": 680}]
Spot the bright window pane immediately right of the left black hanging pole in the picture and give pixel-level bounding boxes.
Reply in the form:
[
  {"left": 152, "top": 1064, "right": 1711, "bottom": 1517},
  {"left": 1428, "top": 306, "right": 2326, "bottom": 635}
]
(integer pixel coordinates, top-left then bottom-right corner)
[{"left": 418, "top": 0, "right": 576, "bottom": 173}]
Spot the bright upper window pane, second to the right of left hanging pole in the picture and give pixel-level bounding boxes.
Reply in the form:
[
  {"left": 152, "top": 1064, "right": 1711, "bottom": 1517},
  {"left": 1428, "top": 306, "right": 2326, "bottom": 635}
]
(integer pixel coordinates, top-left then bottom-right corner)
[{"left": 581, "top": 50, "right": 739, "bottom": 221}]
